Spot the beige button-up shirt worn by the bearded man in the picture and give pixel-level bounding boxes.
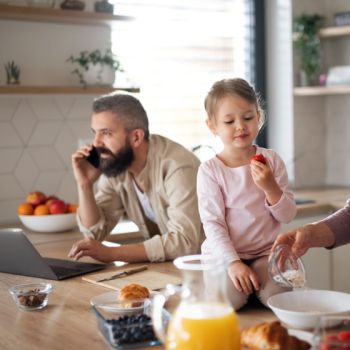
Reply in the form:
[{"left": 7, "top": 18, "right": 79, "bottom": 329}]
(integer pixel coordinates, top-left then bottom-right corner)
[{"left": 78, "top": 135, "right": 204, "bottom": 261}]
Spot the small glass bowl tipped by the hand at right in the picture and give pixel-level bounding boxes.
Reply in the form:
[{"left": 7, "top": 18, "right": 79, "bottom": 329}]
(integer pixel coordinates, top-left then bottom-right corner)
[{"left": 268, "top": 244, "right": 306, "bottom": 289}]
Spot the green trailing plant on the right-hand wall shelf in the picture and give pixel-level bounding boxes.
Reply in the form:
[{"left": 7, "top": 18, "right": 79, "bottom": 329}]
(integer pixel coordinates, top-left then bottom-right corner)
[{"left": 293, "top": 14, "right": 324, "bottom": 85}]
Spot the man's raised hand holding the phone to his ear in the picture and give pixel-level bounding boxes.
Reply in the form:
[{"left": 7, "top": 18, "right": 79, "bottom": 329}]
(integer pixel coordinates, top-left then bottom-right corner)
[{"left": 72, "top": 145, "right": 101, "bottom": 187}]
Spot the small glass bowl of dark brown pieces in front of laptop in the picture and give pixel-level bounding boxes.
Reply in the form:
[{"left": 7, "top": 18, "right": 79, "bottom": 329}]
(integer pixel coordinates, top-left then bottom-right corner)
[{"left": 9, "top": 282, "right": 53, "bottom": 311}]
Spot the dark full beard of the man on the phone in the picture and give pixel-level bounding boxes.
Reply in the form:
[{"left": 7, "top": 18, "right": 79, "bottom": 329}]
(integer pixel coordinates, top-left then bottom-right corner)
[{"left": 96, "top": 139, "right": 135, "bottom": 177}]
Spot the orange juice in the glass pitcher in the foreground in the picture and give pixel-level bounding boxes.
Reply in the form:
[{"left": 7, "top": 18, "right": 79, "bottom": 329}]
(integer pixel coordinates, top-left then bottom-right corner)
[{"left": 166, "top": 303, "right": 241, "bottom": 350}]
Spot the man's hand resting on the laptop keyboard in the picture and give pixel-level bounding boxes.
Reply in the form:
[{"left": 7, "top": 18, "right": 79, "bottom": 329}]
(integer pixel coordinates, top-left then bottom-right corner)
[{"left": 68, "top": 238, "right": 114, "bottom": 263}]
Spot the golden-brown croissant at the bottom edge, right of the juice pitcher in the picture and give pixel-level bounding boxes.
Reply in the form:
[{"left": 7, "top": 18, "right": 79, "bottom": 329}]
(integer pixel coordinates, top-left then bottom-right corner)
[{"left": 241, "top": 321, "right": 311, "bottom": 350}]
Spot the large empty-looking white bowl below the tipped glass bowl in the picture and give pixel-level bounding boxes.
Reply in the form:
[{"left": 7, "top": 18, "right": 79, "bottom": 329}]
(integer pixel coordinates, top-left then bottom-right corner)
[{"left": 267, "top": 289, "right": 350, "bottom": 329}]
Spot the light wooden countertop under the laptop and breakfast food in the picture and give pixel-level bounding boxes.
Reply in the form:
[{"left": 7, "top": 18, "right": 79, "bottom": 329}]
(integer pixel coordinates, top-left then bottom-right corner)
[{"left": 0, "top": 232, "right": 275, "bottom": 350}]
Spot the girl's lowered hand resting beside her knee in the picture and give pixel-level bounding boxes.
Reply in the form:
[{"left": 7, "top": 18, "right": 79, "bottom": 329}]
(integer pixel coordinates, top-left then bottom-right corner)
[{"left": 228, "top": 260, "right": 260, "bottom": 295}]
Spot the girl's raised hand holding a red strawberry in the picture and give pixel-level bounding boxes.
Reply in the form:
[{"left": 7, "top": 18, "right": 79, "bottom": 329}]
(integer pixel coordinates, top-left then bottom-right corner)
[{"left": 250, "top": 160, "right": 283, "bottom": 205}]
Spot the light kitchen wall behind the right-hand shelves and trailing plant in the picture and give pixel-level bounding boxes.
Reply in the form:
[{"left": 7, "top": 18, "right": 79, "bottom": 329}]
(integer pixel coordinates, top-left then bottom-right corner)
[{"left": 293, "top": 0, "right": 350, "bottom": 187}]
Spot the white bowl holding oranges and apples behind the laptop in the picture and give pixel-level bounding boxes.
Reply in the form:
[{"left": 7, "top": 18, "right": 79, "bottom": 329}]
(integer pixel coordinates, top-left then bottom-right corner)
[{"left": 18, "top": 213, "right": 77, "bottom": 232}]
